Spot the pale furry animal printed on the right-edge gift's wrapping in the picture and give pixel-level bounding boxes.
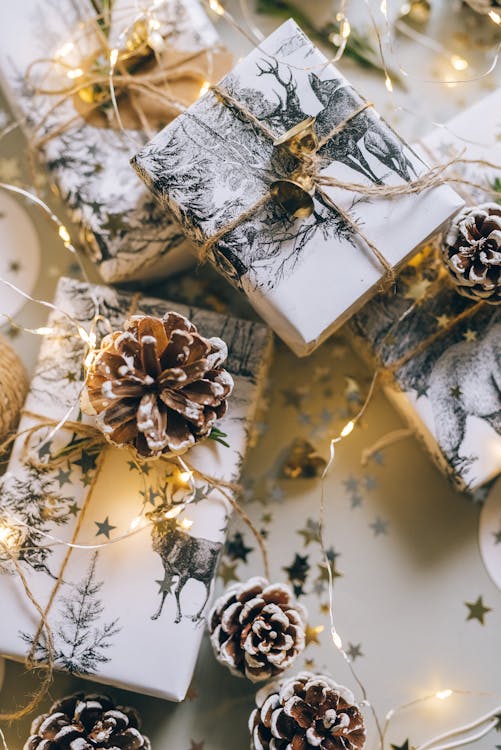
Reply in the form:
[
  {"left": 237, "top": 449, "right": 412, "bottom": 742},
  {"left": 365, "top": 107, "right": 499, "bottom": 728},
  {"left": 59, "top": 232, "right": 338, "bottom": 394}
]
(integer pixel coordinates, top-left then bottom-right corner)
[{"left": 429, "top": 322, "right": 501, "bottom": 476}]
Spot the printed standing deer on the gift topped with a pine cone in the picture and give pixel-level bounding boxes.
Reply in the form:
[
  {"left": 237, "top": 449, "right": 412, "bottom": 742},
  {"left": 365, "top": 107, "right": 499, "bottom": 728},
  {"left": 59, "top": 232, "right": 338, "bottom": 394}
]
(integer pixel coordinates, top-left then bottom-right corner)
[{"left": 149, "top": 506, "right": 223, "bottom": 623}]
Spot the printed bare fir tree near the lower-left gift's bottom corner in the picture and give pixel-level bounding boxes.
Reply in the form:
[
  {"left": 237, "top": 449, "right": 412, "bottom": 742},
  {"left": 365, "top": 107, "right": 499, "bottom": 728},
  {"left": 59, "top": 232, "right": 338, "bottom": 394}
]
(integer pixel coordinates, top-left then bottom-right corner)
[{"left": 21, "top": 552, "right": 121, "bottom": 675}]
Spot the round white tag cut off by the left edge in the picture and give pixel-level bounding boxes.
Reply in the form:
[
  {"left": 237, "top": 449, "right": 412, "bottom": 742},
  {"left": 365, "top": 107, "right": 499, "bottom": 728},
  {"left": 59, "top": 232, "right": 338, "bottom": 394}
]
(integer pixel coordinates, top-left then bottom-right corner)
[{"left": 0, "top": 191, "right": 40, "bottom": 325}]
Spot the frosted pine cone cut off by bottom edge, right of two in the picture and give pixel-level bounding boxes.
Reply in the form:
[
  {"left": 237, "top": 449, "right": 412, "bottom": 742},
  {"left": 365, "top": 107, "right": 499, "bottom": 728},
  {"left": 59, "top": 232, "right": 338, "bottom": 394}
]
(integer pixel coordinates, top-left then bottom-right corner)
[{"left": 249, "top": 672, "right": 365, "bottom": 750}]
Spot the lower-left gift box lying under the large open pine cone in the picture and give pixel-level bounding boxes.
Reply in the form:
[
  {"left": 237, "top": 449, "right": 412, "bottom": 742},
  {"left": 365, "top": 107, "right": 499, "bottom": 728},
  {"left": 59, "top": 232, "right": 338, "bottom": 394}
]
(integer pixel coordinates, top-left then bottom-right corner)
[{"left": 0, "top": 279, "right": 271, "bottom": 701}]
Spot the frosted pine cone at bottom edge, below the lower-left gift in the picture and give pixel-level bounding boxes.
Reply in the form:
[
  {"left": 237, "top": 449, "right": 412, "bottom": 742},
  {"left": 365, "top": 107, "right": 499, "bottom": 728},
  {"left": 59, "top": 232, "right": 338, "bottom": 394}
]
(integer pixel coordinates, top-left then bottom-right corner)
[{"left": 24, "top": 693, "right": 151, "bottom": 750}]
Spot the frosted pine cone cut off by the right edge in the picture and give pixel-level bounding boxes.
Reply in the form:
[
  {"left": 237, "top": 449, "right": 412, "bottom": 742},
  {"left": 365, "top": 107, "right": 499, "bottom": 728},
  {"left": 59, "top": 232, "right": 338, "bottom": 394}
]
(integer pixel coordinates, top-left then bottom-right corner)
[{"left": 442, "top": 203, "right": 501, "bottom": 305}]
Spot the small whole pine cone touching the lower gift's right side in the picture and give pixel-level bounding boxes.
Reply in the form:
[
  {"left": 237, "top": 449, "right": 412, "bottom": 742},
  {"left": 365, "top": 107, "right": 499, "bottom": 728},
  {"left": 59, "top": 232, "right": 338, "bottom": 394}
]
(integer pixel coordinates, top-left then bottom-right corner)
[{"left": 209, "top": 577, "right": 307, "bottom": 682}]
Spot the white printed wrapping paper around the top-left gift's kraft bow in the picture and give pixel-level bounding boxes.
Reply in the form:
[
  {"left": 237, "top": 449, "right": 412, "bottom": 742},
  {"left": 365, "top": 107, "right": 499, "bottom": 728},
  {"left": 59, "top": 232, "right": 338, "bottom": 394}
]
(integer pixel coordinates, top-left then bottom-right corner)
[{"left": 0, "top": 0, "right": 229, "bottom": 282}]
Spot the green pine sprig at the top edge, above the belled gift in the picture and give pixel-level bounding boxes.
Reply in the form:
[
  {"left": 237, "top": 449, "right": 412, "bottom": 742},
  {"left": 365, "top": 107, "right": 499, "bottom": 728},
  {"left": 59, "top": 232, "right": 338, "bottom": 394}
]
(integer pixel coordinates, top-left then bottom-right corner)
[{"left": 256, "top": 0, "right": 405, "bottom": 88}]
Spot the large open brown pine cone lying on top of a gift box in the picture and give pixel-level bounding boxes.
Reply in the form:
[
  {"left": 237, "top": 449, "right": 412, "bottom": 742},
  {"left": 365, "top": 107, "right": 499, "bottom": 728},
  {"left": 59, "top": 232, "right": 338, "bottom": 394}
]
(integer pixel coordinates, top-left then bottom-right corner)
[{"left": 82, "top": 312, "right": 233, "bottom": 456}]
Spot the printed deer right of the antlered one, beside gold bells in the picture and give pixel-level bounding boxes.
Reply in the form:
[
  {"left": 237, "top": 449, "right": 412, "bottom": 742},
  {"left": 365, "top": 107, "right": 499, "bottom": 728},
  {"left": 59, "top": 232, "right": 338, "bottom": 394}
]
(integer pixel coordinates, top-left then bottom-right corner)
[{"left": 308, "top": 73, "right": 416, "bottom": 184}]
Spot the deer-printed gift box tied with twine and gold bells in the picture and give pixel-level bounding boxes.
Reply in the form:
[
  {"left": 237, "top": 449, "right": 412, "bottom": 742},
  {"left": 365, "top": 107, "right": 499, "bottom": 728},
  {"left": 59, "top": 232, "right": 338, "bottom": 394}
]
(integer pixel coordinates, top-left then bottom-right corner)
[{"left": 133, "top": 20, "right": 461, "bottom": 356}]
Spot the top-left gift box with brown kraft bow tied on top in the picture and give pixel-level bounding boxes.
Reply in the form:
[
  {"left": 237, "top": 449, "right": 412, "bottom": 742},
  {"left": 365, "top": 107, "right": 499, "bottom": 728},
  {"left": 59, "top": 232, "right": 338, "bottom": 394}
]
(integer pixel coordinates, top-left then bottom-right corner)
[{"left": 0, "top": 0, "right": 231, "bottom": 282}]
